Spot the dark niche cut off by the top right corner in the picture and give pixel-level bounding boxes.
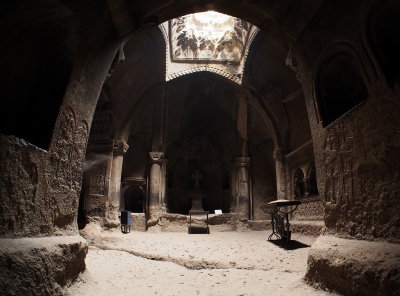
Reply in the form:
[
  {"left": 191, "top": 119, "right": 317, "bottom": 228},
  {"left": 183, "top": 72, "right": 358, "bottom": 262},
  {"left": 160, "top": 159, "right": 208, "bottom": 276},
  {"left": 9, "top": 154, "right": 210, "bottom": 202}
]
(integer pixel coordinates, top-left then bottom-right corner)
[{"left": 368, "top": 0, "right": 400, "bottom": 86}]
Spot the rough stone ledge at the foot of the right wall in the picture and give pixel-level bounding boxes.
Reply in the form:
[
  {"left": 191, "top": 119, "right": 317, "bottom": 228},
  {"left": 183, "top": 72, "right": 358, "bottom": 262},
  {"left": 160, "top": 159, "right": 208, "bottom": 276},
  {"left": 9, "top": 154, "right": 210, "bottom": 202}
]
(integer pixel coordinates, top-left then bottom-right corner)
[{"left": 305, "top": 235, "right": 400, "bottom": 296}]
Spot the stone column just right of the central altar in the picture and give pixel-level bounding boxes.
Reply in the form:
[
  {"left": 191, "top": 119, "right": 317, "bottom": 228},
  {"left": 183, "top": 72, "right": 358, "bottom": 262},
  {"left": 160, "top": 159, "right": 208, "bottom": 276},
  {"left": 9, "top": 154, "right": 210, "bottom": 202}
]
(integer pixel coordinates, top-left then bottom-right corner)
[{"left": 235, "top": 157, "right": 250, "bottom": 220}]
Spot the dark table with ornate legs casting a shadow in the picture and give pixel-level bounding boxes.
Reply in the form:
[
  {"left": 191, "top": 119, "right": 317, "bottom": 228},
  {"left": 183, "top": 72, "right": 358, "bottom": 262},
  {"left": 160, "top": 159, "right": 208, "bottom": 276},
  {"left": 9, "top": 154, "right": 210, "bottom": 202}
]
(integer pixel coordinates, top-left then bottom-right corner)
[{"left": 261, "top": 199, "right": 301, "bottom": 241}]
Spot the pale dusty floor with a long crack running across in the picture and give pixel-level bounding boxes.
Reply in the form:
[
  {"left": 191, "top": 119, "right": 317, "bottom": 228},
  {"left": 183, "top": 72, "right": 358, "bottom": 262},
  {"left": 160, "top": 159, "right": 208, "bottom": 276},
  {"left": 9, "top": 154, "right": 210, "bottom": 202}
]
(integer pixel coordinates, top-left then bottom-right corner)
[{"left": 67, "top": 225, "right": 335, "bottom": 296}]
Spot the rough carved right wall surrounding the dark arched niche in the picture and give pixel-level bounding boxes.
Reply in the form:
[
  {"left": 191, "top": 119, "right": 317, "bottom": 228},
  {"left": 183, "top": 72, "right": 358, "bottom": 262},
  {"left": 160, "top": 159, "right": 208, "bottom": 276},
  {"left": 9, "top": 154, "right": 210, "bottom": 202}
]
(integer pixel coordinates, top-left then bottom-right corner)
[{"left": 294, "top": 0, "right": 400, "bottom": 240}]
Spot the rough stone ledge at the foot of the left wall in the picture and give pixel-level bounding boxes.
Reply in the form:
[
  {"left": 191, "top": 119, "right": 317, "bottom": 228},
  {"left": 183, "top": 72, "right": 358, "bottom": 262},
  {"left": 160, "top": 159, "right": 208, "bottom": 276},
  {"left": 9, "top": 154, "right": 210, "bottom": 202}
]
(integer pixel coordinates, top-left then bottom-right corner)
[{"left": 0, "top": 236, "right": 88, "bottom": 296}]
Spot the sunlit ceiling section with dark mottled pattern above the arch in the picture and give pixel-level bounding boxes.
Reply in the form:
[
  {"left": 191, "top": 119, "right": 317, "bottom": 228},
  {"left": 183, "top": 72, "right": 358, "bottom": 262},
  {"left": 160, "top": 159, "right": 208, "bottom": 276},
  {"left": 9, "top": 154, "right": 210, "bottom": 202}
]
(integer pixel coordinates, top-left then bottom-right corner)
[{"left": 160, "top": 11, "right": 258, "bottom": 84}]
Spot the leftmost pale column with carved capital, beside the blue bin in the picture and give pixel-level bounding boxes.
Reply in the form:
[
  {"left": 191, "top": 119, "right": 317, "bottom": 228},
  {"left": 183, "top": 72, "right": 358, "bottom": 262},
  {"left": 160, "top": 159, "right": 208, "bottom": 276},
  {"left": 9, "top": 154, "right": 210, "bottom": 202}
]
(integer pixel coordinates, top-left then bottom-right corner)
[{"left": 105, "top": 141, "right": 129, "bottom": 227}]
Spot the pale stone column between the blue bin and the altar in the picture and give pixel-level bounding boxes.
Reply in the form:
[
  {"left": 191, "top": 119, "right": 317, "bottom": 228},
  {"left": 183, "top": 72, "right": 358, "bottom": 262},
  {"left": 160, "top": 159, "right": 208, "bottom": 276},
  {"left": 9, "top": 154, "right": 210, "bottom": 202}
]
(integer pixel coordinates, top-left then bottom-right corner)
[{"left": 148, "top": 152, "right": 164, "bottom": 224}]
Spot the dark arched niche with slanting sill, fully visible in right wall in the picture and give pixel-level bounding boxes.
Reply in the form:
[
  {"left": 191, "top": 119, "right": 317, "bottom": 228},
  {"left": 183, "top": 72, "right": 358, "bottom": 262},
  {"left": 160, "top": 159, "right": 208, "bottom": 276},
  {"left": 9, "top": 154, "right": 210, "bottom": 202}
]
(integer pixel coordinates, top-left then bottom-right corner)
[{"left": 316, "top": 50, "right": 368, "bottom": 127}]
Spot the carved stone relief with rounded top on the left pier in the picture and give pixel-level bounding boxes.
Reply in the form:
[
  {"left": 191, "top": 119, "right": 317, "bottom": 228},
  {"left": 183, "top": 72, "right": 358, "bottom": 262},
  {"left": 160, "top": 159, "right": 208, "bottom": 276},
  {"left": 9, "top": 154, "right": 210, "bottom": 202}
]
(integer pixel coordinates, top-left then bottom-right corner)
[{"left": 49, "top": 107, "right": 89, "bottom": 191}]
